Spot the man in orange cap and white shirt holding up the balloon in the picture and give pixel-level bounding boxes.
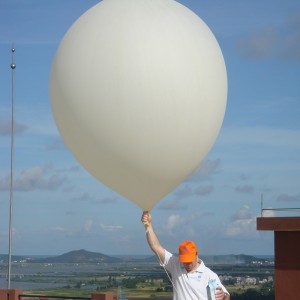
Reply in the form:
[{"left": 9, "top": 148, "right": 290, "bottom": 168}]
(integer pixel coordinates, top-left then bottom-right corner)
[{"left": 141, "top": 212, "right": 230, "bottom": 300}]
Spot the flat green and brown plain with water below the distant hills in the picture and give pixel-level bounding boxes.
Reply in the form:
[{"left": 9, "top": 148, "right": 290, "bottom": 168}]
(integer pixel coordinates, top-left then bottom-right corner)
[{"left": 0, "top": 262, "right": 274, "bottom": 300}]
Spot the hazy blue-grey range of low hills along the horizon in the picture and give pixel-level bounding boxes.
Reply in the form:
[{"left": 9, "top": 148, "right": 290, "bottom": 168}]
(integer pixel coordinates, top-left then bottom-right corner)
[{"left": 0, "top": 249, "right": 272, "bottom": 265}]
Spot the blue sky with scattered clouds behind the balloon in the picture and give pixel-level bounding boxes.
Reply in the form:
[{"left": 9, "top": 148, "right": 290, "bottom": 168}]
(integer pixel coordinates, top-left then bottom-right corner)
[{"left": 0, "top": 0, "right": 300, "bottom": 255}]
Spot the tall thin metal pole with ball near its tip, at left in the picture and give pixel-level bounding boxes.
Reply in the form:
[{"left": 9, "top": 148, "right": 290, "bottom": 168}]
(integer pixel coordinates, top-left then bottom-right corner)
[{"left": 7, "top": 47, "right": 16, "bottom": 289}]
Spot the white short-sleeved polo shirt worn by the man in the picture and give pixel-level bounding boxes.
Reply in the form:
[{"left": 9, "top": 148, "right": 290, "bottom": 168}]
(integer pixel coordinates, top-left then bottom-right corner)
[{"left": 163, "top": 251, "right": 228, "bottom": 300}]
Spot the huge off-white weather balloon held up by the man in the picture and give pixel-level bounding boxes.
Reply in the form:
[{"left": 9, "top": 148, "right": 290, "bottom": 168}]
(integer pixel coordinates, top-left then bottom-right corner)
[{"left": 50, "top": 0, "right": 227, "bottom": 210}]
